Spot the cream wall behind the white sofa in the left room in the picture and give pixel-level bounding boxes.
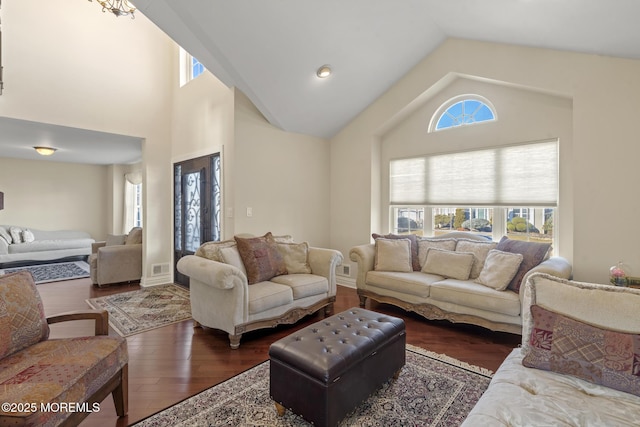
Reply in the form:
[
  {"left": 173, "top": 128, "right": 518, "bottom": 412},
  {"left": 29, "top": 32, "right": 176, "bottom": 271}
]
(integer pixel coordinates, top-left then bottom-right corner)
[{"left": 0, "top": 158, "right": 109, "bottom": 240}]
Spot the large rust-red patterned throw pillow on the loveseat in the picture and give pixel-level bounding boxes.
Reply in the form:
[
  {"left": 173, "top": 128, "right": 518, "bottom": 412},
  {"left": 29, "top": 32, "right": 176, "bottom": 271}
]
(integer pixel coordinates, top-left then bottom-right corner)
[{"left": 234, "top": 232, "right": 287, "bottom": 285}]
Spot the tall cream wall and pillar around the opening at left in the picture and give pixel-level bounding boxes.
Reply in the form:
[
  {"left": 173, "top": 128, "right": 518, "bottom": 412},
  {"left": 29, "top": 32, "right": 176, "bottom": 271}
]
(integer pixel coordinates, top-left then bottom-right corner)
[{"left": 0, "top": 0, "right": 177, "bottom": 283}]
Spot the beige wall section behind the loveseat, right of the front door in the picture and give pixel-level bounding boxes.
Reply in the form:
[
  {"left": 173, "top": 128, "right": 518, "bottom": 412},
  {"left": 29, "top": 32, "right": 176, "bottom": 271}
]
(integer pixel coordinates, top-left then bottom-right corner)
[{"left": 232, "top": 91, "right": 330, "bottom": 247}]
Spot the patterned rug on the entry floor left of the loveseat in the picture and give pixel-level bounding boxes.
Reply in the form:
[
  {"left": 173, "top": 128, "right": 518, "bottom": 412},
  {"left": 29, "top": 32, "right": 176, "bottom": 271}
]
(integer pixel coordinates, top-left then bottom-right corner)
[{"left": 87, "top": 284, "right": 191, "bottom": 337}]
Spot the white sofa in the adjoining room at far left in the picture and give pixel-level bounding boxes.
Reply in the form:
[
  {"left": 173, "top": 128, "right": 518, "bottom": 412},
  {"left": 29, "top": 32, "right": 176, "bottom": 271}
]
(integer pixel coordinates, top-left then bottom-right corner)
[{"left": 0, "top": 225, "right": 95, "bottom": 266}]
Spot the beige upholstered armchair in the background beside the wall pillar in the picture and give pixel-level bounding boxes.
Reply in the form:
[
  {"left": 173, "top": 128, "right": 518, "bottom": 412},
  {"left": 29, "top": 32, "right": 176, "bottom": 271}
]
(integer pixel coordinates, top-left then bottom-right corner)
[{"left": 89, "top": 227, "right": 142, "bottom": 287}]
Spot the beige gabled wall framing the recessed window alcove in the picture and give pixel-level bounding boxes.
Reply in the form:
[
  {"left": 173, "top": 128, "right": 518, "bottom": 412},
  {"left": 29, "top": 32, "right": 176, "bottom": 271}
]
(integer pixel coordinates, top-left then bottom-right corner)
[{"left": 331, "top": 39, "right": 640, "bottom": 282}]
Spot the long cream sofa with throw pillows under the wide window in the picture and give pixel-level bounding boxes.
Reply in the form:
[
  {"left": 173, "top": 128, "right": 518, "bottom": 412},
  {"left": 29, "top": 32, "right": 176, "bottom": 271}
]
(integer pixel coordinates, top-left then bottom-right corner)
[{"left": 349, "top": 232, "right": 571, "bottom": 334}]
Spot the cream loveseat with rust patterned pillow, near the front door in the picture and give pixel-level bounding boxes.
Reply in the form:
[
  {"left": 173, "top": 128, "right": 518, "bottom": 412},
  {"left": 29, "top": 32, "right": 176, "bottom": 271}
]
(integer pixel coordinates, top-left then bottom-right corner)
[{"left": 177, "top": 233, "right": 343, "bottom": 349}]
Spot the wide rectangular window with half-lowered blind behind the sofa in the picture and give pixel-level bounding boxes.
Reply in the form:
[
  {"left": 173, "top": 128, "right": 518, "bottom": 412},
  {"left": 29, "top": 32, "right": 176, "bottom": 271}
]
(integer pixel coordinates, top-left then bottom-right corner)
[{"left": 389, "top": 140, "right": 558, "bottom": 246}]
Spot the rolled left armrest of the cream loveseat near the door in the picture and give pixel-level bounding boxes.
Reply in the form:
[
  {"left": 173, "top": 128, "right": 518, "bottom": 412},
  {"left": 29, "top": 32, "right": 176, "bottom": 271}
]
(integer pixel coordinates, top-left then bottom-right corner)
[{"left": 177, "top": 255, "right": 249, "bottom": 289}]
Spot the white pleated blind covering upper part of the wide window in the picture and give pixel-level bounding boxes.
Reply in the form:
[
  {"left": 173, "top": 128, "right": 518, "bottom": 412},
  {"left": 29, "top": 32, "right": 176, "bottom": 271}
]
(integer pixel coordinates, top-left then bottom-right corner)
[{"left": 389, "top": 140, "right": 558, "bottom": 207}]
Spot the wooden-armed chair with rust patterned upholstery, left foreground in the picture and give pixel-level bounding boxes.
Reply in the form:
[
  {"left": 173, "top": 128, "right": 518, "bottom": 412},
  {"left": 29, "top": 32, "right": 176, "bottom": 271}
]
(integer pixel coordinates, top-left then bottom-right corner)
[{"left": 0, "top": 270, "right": 128, "bottom": 426}]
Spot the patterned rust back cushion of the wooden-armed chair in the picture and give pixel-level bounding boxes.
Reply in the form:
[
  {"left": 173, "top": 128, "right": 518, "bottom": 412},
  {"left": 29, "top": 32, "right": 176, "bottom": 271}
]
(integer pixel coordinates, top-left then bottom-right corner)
[{"left": 0, "top": 271, "right": 49, "bottom": 360}]
